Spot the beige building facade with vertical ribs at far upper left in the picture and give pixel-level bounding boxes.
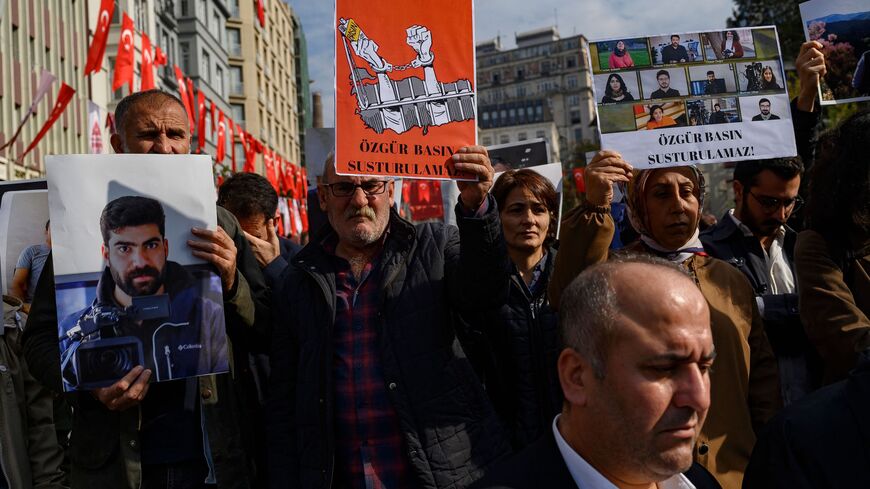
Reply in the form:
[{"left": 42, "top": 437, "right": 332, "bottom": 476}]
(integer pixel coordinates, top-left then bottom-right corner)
[{"left": 0, "top": 0, "right": 95, "bottom": 180}]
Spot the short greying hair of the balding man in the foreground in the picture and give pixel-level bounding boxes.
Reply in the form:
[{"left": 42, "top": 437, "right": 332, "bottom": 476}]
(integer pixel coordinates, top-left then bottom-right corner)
[{"left": 559, "top": 252, "right": 688, "bottom": 379}]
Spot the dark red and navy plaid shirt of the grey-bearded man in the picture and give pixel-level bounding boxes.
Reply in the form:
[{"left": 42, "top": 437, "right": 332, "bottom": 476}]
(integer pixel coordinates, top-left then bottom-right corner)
[{"left": 325, "top": 244, "right": 411, "bottom": 489}]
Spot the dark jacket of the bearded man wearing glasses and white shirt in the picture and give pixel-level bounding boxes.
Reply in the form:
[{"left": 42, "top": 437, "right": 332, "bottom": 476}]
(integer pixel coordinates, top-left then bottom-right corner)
[{"left": 701, "top": 212, "right": 812, "bottom": 356}]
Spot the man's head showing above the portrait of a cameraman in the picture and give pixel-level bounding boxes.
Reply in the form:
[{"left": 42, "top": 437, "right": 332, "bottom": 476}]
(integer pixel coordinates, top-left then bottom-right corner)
[{"left": 111, "top": 89, "right": 190, "bottom": 154}]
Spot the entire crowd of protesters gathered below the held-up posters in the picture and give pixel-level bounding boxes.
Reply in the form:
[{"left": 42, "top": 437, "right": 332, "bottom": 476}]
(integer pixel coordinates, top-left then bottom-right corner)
[{"left": 0, "top": 36, "right": 870, "bottom": 489}]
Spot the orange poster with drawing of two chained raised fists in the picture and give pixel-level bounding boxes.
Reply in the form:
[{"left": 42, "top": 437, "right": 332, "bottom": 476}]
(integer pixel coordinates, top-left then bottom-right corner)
[{"left": 334, "top": 0, "right": 477, "bottom": 179}]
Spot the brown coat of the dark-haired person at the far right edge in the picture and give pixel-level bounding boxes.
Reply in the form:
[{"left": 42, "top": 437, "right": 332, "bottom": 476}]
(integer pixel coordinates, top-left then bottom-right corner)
[{"left": 794, "top": 230, "right": 870, "bottom": 383}]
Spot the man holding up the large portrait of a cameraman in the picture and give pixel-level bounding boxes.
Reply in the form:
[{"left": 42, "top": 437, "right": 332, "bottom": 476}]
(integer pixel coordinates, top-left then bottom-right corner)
[{"left": 24, "top": 90, "right": 271, "bottom": 489}]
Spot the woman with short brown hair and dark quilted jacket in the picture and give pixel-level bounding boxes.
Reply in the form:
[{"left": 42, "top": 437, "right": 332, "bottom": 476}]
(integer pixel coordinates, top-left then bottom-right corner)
[{"left": 463, "top": 169, "right": 562, "bottom": 449}]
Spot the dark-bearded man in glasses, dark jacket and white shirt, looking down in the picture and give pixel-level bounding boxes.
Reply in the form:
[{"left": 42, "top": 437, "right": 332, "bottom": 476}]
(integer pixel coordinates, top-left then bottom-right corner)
[{"left": 701, "top": 157, "right": 820, "bottom": 404}]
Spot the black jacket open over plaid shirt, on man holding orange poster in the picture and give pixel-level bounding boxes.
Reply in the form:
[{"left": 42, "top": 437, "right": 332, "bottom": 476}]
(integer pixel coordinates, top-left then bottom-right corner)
[{"left": 268, "top": 197, "right": 510, "bottom": 489}]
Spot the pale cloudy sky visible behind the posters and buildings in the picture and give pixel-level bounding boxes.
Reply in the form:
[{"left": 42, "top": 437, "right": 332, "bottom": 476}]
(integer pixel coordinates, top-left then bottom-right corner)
[{"left": 287, "top": 0, "right": 733, "bottom": 127}]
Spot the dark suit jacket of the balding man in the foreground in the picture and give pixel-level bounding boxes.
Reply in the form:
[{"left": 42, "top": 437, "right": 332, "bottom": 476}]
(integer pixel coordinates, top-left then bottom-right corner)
[{"left": 472, "top": 426, "right": 721, "bottom": 489}]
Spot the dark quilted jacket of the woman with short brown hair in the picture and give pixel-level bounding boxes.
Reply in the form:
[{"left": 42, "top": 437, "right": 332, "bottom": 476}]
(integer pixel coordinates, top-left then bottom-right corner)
[{"left": 462, "top": 249, "right": 562, "bottom": 450}]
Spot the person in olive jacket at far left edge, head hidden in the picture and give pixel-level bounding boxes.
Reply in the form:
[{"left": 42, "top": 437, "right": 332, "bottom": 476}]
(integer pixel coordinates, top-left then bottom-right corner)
[{"left": 0, "top": 295, "right": 66, "bottom": 489}]
